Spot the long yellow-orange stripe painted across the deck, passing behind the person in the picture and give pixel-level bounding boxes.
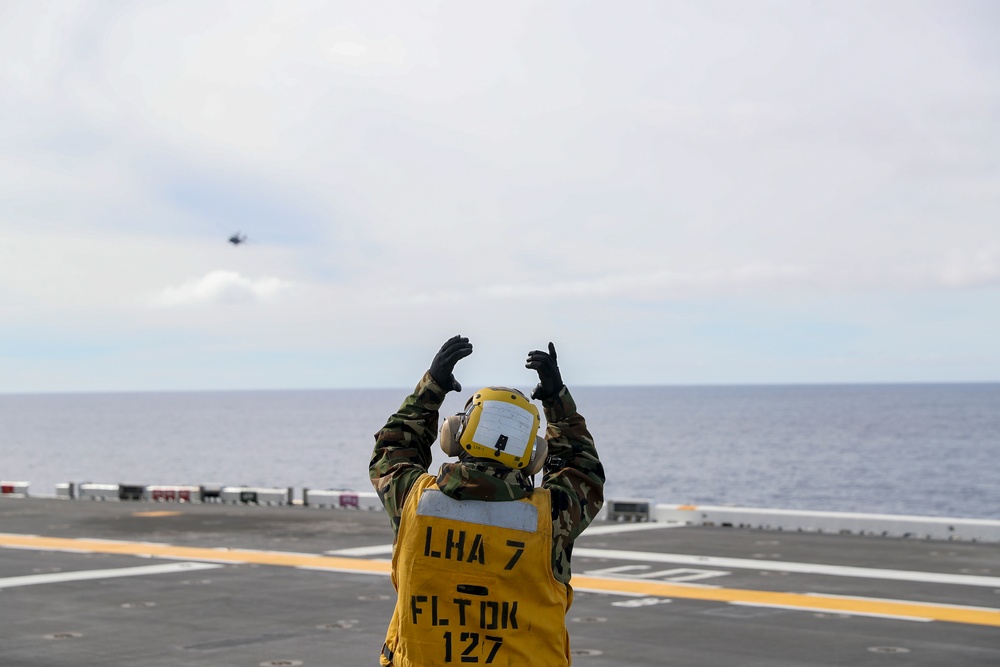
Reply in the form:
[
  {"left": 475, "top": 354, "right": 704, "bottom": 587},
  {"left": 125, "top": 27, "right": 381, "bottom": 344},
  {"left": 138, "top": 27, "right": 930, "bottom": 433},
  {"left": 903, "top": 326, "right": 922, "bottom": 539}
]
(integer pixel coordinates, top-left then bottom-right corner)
[{"left": 0, "top": 534, "right": 1000, "bottom": 627}]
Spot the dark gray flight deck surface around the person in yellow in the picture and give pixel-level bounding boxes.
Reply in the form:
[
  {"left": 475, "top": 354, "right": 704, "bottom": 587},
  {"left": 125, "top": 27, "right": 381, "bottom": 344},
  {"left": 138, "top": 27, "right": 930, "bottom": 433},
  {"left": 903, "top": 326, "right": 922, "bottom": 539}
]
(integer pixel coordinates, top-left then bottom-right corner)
[{"left": 0, "top": 498, "right": 1000, "bottom": 667}]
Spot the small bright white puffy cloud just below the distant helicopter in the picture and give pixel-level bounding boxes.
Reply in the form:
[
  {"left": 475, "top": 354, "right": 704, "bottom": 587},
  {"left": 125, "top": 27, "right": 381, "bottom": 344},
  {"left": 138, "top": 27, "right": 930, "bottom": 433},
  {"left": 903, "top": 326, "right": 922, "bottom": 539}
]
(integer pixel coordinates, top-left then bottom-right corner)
[{"left": 153, "top": 270, "right": 294, "bottom": 308}]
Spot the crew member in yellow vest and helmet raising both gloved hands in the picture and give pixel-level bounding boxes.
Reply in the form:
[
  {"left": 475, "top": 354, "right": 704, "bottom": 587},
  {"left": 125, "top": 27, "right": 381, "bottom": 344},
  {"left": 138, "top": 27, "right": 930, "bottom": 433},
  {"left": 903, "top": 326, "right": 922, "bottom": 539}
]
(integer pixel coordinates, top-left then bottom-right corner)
[{"left": 369, "top": 336, "right": 604, "bottom": 667}]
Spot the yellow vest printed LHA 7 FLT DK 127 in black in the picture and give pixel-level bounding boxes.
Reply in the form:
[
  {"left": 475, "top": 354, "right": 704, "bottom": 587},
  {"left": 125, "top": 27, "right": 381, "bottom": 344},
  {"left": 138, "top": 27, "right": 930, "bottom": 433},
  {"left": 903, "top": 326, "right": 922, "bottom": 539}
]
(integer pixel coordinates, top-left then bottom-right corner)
[{"left": 381, "top": 475, "right": 573, "bottom": 667}]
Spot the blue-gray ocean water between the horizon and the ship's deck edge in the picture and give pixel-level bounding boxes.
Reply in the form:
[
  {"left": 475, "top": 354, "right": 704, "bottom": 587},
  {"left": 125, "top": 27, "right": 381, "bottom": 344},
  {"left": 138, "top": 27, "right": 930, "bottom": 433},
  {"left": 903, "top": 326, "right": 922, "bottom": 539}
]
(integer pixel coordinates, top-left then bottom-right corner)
[{"left": 0, "top": 384, "right": 1000, "bottom": 519}]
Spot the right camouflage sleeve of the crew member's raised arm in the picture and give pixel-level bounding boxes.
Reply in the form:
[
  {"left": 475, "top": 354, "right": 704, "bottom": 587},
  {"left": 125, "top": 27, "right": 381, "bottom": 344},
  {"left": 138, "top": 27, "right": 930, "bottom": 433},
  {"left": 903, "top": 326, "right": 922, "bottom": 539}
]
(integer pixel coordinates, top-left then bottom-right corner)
[{"left": 542, "top": 386, "right": 605, "bottom": 583}]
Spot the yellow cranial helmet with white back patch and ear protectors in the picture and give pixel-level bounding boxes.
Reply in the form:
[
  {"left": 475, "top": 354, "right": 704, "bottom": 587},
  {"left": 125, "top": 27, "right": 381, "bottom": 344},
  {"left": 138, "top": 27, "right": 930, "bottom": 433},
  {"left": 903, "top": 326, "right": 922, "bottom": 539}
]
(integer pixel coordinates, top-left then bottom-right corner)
[{"left": 441, "top": 387, "right": 548, "bottom": 475}]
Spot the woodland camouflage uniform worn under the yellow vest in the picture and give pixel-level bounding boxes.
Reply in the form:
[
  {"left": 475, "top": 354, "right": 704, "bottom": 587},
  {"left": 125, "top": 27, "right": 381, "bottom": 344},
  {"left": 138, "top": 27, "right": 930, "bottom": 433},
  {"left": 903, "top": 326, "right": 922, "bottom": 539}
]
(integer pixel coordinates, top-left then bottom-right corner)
[{"left": 368, "top": 373, "right": 604, "bottom": 584}]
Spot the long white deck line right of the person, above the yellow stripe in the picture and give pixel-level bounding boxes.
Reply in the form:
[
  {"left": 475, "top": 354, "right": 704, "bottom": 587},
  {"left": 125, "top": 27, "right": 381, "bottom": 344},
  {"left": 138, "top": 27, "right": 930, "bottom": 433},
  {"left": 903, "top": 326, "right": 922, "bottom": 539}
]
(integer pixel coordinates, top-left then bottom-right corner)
[{"left": 573, "top": 547, "right": 1000, "bottom": 588}]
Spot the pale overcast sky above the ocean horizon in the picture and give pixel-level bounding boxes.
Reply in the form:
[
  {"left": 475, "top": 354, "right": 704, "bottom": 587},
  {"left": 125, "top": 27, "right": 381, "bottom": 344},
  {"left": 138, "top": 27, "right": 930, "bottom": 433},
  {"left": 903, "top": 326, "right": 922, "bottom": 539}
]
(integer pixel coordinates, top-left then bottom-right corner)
[{"left": 0, "top": 0, "right": 1000, "bottom": 393}]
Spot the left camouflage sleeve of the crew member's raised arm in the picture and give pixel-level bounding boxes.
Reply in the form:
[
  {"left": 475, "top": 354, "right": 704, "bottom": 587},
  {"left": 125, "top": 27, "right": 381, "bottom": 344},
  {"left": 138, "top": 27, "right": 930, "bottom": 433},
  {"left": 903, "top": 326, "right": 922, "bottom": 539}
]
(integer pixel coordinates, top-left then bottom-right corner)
[{"left": 368, "top": 373, "right": 446, "bottom": 533}]
